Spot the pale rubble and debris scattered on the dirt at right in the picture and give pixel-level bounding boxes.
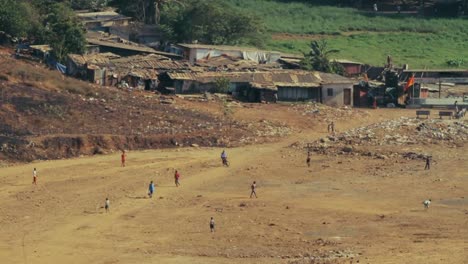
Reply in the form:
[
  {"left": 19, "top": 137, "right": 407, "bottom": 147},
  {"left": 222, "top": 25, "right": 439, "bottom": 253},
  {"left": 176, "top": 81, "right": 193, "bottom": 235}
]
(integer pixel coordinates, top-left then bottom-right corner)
[{"left": 292, "top": 117, "right": 468, "bottom": 159}]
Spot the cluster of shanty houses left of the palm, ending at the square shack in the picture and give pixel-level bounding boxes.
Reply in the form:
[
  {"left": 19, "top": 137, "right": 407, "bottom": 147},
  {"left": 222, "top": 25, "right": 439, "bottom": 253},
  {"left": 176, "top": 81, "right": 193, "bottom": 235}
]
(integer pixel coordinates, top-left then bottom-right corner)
[{"left": 62, "top": 12, "right": 358, "bottom": 106}]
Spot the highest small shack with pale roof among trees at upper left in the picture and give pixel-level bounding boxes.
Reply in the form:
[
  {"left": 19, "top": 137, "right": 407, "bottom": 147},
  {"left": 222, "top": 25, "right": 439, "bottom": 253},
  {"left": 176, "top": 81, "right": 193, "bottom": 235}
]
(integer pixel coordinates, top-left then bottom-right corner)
[{"left": 77, "top": 11, "right": 132, "bottom": 32}]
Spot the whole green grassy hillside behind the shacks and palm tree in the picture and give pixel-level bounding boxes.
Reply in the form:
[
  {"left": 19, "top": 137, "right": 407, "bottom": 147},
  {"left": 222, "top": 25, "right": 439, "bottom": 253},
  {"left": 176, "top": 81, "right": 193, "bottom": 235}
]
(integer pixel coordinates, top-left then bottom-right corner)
[{"left": 224, "top": 0, "right": 468, "bottom": 68}]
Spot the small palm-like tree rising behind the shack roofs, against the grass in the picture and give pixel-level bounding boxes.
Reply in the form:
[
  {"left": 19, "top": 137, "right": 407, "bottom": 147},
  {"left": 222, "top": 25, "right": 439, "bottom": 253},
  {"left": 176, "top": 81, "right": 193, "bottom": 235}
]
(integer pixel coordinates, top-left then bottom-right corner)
[{"left": 300, "top": 40, "right": 344, "bottom": 74}]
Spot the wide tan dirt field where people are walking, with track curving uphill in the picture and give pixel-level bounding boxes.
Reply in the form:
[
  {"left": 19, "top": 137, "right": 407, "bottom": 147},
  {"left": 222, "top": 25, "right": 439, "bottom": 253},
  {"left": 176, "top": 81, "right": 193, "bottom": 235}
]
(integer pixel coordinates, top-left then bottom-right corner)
[{"left": 0, "top": 108, "right": 468, "bottom": 264}]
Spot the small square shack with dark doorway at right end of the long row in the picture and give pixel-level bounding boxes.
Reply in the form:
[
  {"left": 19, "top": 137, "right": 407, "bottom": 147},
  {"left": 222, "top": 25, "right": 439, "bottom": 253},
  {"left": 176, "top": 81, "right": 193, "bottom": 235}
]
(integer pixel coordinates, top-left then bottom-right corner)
[{"left": 320, "top": 73, "right": 354, "bottom": 106}]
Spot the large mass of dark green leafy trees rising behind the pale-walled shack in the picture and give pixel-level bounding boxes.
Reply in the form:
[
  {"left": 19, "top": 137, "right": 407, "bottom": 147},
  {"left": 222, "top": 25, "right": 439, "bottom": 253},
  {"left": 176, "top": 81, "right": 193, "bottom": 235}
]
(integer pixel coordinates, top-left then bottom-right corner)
[{"left": 110, "top": 0, "right": 267, "bottom": 46}]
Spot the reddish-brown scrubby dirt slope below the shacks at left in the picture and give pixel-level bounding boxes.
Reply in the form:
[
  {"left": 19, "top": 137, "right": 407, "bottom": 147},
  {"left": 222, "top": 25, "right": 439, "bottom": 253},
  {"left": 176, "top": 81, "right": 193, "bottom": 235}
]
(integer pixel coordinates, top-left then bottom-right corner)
[{"left": 0, "top": 54, "right": 287, "bottom": 161}]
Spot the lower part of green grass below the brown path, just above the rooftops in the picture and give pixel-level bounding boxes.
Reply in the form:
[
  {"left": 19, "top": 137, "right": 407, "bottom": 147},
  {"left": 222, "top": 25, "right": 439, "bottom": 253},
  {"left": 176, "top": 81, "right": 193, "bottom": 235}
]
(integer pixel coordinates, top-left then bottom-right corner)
[{"left": 267, "top": 33, "right": 468, "bottom": 68}]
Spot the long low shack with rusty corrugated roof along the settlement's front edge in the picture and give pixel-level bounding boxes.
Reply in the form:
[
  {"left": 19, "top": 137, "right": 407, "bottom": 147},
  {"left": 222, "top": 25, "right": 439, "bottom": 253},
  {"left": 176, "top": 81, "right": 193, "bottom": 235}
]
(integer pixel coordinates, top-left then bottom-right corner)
[{"left": 168, "top": 70, "right": 353, "bottom": 105}]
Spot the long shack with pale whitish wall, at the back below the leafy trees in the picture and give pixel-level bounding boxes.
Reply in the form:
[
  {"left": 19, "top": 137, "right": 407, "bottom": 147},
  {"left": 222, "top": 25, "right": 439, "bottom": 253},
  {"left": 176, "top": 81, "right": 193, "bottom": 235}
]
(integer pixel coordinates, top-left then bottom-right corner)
[{"left": 173, "top": 44, "right": 280, "bottom": 64}]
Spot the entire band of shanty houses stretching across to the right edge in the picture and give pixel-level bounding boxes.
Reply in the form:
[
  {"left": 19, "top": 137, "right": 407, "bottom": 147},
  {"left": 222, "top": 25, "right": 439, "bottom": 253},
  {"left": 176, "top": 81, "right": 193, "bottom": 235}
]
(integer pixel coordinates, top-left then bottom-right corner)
[{"left": 12, "top": 11, "right": 468, "bottom": 108}]
